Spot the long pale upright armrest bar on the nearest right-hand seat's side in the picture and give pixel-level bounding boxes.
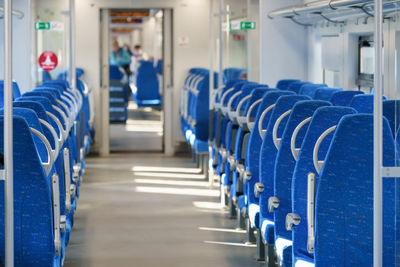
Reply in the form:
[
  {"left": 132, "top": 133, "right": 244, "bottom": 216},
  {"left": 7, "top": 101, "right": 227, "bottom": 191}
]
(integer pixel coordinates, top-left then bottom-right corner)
[{"left": 307, "top": 172, "right": 315, "bottom": 253}]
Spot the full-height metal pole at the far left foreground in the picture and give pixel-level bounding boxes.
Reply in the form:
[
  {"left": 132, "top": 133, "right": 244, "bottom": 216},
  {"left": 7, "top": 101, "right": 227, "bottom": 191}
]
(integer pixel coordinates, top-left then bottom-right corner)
[{"left": 4, "top": 0, "right": 14, "bottom": 267}]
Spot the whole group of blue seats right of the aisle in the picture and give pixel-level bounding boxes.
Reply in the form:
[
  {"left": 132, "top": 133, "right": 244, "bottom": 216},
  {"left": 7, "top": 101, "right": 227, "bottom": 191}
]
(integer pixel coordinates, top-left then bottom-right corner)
[{"left": 180, "top": 69, "right": 400, "bottom": 266}]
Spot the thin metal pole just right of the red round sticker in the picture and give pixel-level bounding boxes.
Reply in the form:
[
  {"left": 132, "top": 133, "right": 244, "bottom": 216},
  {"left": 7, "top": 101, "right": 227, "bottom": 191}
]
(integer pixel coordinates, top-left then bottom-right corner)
[{"left": 69, "top": 0, "right": 76, "bottom": 88}]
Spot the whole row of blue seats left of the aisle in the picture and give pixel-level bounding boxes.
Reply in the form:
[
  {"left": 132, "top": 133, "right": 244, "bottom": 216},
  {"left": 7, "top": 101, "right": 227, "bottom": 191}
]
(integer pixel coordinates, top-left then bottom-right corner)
[{"left": 0, "top": 76, "right": 91, "bottom": 266}]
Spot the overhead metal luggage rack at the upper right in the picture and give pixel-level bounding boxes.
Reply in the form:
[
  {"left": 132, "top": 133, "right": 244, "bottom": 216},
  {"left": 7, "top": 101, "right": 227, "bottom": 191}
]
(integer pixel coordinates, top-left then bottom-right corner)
[{"left": 268, "top": 0, "right": 400, "bottom": 26}]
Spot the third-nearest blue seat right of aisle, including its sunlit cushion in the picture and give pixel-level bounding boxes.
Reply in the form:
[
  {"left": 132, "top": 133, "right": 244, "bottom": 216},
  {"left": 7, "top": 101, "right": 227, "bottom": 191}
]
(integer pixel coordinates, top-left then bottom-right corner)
[{"left": 269, "top": 100, "right": 331, "bottom": 267}]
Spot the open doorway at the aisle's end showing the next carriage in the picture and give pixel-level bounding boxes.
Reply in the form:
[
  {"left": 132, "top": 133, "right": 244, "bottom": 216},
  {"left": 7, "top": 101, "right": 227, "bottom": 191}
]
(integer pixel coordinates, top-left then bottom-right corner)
[{"left": 101, "top": 9, "right": 172, "bottom": 152}]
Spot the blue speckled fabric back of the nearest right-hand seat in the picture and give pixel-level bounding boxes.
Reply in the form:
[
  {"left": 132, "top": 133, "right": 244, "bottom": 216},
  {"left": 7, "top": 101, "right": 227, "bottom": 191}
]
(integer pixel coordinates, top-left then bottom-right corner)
[{"left": 315, "top": 114, "right": 400, "bottom": 267}]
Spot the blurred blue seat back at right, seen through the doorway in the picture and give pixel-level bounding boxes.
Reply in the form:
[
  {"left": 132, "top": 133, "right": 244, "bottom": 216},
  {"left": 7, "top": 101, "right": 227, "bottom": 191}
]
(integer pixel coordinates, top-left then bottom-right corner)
[{"left": 136, "top": 61, "right": 160, "bottom": 100}]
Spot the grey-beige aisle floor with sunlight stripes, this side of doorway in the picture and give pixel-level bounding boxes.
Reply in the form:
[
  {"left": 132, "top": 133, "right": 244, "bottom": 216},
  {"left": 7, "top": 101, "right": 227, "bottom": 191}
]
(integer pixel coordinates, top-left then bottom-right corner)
[{"left": 64, "top": 153, "right": 261, "bottom": 267}]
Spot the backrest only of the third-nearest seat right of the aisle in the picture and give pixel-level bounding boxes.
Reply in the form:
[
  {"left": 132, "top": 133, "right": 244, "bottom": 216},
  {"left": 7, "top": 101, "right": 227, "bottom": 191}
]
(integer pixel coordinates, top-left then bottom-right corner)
[{"left": 274, "top": 100, "right": 331, "bottom": 240}]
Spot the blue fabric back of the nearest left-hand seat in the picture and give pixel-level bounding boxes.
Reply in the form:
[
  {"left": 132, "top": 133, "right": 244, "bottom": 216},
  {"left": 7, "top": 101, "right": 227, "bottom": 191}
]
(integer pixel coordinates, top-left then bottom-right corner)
[{"left": 0, "top": 116, "right": 61, "bottom": 267}]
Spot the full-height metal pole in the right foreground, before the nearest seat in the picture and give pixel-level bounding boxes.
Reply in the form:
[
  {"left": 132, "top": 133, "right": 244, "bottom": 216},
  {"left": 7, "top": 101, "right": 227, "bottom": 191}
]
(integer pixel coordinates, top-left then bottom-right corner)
[{"left": 374, "top": 0, "right": 383, "bottom": 267}]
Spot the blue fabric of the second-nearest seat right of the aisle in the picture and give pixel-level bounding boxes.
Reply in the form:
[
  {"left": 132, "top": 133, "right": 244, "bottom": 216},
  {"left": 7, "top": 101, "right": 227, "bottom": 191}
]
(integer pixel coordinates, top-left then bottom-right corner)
[{"left": 291, "top": 107, "right": 356, "bottom": 265}]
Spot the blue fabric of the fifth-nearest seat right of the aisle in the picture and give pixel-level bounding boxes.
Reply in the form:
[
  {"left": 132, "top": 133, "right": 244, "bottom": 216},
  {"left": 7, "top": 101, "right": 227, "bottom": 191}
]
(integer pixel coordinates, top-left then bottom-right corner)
[{"left": 245, "top": 90, "right": 294, "bottom": 229}]
